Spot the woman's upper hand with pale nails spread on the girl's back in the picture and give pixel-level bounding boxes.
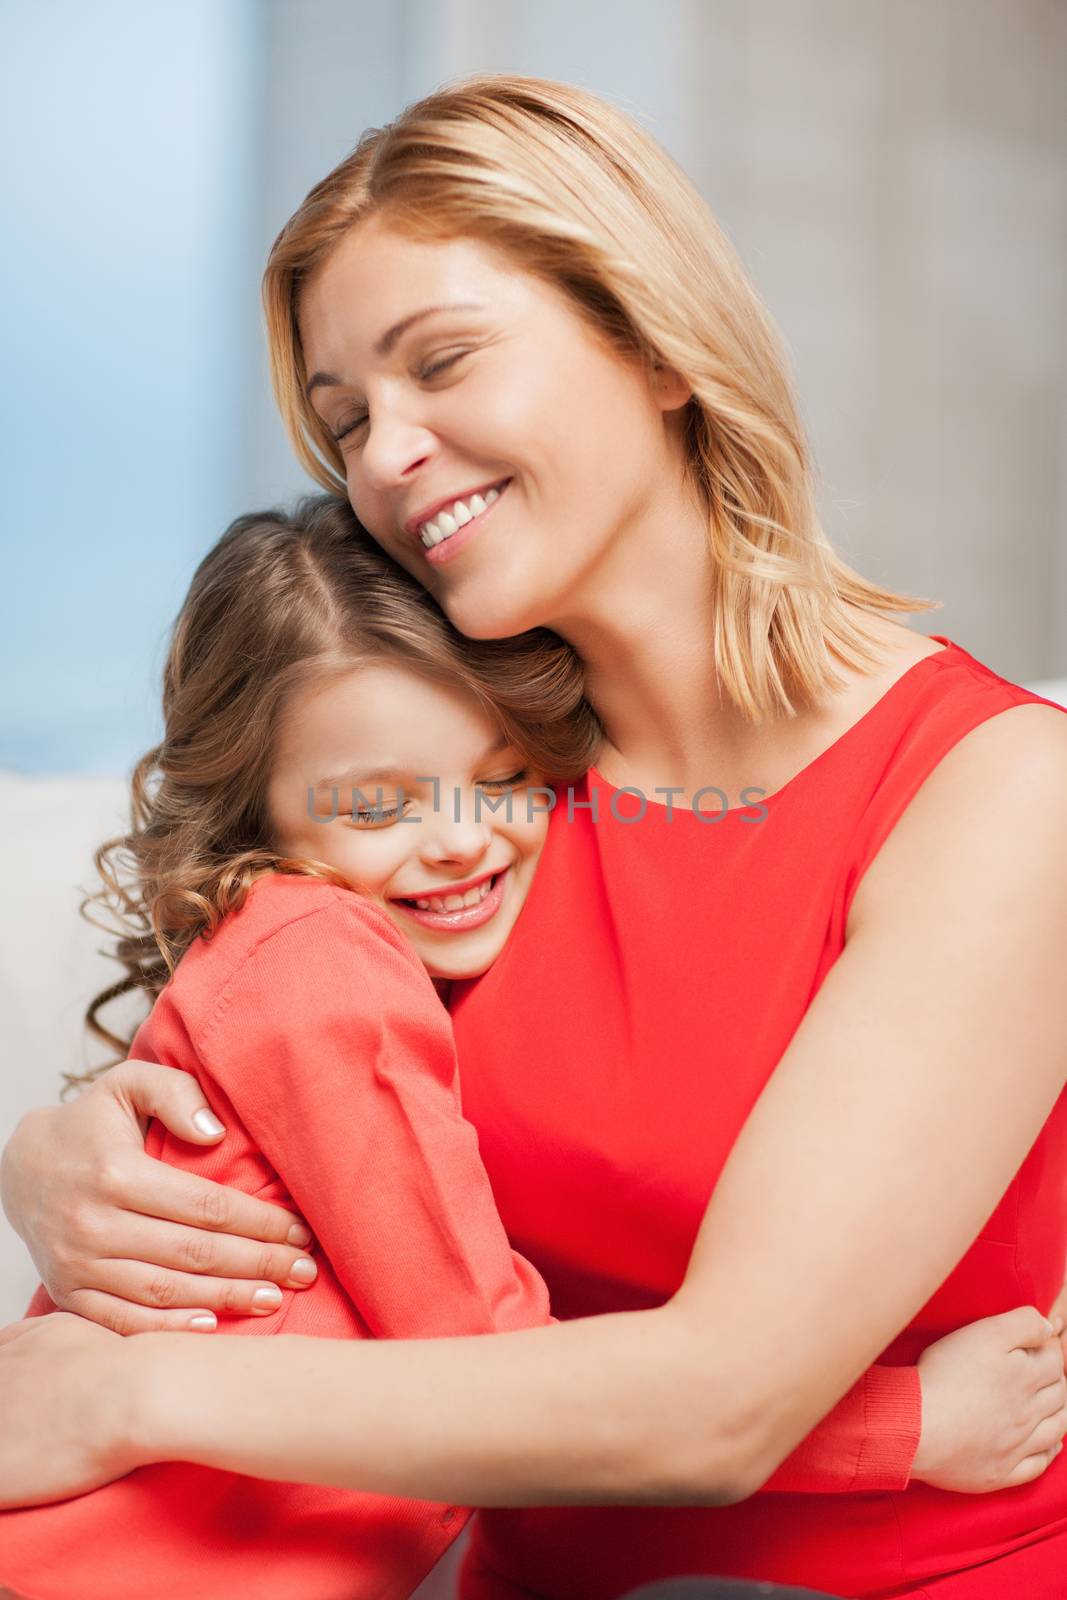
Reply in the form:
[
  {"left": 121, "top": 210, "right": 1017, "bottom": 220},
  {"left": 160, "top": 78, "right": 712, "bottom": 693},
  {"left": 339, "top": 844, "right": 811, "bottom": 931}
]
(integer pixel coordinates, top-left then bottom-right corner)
[{"left": 0, "top": 1061, "right": 315, "bottom": 1334}]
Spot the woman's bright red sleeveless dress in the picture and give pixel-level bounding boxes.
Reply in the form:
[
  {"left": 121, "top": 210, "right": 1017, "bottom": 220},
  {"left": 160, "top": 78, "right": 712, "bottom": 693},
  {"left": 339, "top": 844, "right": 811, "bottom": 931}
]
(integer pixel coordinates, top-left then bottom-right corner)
[{"left": 451, "top": 635, "right": 1067, "bottom": 1600}]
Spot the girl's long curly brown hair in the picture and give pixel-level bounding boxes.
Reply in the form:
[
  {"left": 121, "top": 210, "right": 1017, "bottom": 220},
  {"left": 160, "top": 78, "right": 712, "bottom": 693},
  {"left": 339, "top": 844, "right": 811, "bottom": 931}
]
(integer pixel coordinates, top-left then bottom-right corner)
[{"left": 80, "top": 494, "right": 600, "bottom": 1088}]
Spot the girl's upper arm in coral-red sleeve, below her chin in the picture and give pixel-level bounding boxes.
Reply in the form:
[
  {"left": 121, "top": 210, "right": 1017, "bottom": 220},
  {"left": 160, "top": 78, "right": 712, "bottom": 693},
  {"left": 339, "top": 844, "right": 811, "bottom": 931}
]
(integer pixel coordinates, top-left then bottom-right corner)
[{"left": 183, "top": 878, "right": 550, "bottom": 1338}]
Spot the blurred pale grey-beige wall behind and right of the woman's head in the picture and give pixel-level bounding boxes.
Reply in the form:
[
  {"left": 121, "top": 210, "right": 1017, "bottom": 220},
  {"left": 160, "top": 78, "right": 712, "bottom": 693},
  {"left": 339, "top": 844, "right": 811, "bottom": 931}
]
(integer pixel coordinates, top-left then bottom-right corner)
[{"left": 258, "top": 0, "right": 1067, "bottom": 680}]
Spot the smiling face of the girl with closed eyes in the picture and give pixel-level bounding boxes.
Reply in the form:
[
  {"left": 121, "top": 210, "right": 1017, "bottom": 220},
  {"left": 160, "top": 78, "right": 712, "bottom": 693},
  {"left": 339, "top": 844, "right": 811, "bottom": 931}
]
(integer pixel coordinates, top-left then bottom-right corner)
[{"left": 267, "top": 659, "right": 547, "bottom": 978}]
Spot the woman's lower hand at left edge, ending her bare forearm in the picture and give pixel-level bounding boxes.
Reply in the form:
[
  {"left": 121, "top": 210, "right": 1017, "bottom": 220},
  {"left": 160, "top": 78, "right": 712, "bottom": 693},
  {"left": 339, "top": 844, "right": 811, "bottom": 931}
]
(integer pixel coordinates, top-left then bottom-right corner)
[{"left": 0, "top": 1312, "right": 141, "bottom": 1509}]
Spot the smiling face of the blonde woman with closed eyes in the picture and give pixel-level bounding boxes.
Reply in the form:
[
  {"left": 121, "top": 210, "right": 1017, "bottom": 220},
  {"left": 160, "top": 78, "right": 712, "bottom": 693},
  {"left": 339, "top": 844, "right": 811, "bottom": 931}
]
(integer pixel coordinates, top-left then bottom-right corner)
[{"left": 299, "top": 219, "right": 694, "bottom": 638}]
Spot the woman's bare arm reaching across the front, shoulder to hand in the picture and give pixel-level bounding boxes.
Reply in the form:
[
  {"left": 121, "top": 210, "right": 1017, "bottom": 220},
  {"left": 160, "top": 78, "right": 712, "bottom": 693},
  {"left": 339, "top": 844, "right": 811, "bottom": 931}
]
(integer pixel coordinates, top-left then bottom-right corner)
[{"left": 0, "top": 707, "right": 1067, "bottom": 1506}]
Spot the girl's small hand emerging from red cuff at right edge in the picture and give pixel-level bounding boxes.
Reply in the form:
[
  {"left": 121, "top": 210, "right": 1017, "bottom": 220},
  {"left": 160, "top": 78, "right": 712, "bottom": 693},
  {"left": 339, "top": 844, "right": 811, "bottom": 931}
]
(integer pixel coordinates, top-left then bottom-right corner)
[{"left": 912, "top": 1306, "right": 1067, "bottom": 1494}]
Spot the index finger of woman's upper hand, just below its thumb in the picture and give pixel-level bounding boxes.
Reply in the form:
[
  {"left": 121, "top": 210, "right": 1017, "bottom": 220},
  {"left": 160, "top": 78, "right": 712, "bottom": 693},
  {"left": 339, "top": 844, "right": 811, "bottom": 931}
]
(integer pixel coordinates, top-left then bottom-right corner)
[{"left": 115, "top": 1158, "right": 310, "bottom": 1254}]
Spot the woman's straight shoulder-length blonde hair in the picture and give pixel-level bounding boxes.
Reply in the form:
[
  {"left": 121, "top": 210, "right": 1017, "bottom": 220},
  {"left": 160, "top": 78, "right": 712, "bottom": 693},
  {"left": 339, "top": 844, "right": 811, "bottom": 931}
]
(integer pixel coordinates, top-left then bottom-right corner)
[{"left": 262, "top": 74, "right": 939, "bottom": 722}]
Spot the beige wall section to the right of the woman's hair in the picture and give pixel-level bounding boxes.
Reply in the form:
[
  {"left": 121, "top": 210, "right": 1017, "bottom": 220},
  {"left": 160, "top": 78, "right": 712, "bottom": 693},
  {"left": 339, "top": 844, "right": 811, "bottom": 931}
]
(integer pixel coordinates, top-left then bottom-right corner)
[{"left": 677, "top": 0, "right": 1067, "bottom": 678}]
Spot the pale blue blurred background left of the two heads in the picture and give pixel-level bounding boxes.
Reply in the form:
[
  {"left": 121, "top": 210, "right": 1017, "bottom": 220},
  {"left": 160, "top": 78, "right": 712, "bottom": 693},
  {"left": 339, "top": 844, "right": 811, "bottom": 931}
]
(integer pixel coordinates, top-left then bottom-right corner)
[{"left": 0, "top": 0, "right": 261, "bottom": 771}]
